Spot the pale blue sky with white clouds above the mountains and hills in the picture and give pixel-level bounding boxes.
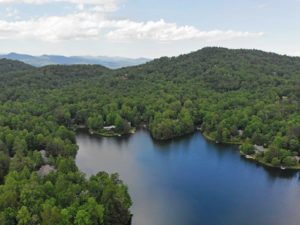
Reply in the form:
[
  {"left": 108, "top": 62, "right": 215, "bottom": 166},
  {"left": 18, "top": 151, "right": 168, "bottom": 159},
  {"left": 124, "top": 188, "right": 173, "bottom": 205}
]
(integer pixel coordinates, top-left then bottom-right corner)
[{"left": 0, "top": 0, "right": 300, "bottom": 58}]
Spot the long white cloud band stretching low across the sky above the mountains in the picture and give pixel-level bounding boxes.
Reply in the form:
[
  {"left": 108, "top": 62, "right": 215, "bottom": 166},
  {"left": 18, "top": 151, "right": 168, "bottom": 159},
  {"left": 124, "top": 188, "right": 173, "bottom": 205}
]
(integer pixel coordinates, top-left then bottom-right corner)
[{"left": 0, "top": 11, "right": 263, "bottom": 42}]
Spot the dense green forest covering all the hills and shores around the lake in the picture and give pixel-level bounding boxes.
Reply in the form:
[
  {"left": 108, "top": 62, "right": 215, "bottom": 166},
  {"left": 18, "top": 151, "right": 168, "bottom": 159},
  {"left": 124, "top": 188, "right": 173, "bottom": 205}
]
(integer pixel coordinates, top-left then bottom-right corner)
[{"left": 0, "top": 48, "right": 300, "bottom": 225}]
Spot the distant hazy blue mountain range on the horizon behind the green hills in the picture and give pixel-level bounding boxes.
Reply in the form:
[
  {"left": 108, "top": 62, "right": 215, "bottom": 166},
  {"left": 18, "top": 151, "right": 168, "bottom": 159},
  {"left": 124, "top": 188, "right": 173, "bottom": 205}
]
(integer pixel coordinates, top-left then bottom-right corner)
[{"left": 0, "top": 53, "right": 151, "bottom": 69}]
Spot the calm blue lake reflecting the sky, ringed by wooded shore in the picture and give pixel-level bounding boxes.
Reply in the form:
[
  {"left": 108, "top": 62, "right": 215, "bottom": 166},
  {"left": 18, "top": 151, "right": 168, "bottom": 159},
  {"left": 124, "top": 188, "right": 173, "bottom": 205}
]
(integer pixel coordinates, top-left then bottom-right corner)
[{"left": 76, "top": 130, "right": 300, "bottom": 225}]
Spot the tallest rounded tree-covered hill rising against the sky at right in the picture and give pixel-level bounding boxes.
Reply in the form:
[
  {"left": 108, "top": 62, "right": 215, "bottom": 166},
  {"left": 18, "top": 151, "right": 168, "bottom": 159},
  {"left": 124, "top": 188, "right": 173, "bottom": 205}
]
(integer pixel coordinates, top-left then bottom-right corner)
[{"left": 121, "top": 47, "right": 300, "bottom": 92}]
